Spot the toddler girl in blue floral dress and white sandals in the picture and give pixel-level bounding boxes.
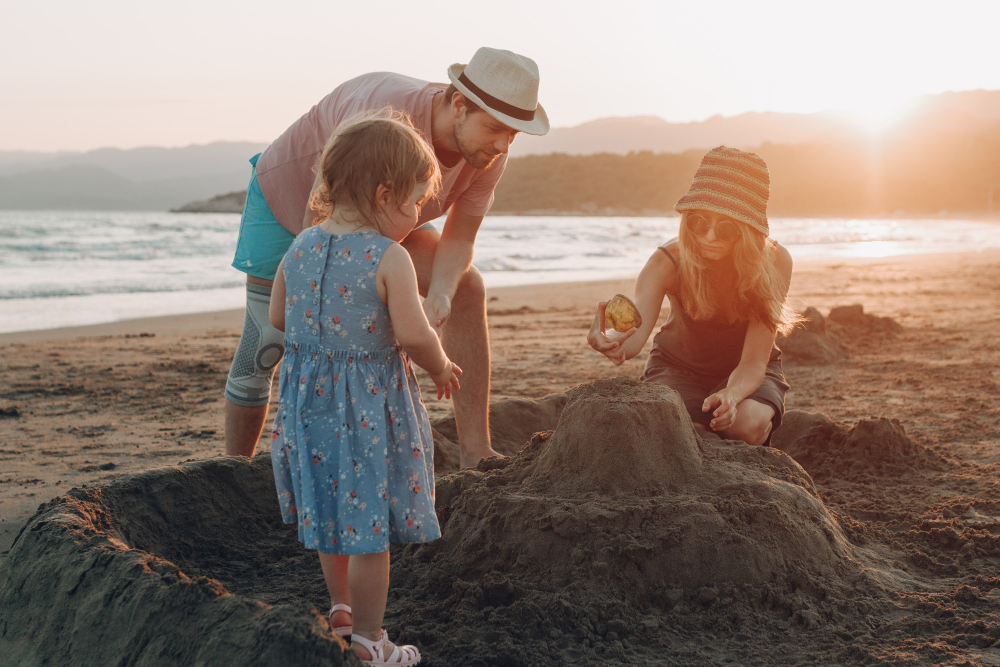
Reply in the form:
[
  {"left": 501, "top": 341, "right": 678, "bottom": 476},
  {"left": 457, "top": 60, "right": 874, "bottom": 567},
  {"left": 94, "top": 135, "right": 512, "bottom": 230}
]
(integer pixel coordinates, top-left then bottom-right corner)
[{"left": 270, "top": 112, "right": 462, "bottom": 665}]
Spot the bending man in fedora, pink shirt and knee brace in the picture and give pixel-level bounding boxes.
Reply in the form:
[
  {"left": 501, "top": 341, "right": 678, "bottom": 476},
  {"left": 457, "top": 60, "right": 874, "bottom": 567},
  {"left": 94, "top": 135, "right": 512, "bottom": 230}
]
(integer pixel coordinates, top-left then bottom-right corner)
[{"left": 226, "top": 47, "right": 549, "bottom": 467}]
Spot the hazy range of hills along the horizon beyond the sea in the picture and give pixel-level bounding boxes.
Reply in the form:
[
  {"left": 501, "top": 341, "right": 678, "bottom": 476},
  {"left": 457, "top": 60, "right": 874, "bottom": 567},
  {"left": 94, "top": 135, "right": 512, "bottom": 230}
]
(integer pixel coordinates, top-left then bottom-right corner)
[{"left": 0, "top": 90, "right": 1000, "bottom": 215}]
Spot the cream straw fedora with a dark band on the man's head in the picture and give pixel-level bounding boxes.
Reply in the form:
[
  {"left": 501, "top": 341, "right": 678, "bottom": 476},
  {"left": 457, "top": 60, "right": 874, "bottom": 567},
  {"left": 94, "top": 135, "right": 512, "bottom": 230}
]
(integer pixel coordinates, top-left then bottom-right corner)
[{"left": 448, "top": 46, "right": 549, "bottom": 135}]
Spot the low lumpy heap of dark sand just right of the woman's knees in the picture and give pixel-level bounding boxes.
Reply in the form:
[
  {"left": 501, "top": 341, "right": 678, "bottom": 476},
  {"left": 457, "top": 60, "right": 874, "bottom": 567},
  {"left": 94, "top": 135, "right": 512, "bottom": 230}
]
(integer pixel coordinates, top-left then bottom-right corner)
[{"left": 772, "top": 410, "right": 939, "bottom": 479}]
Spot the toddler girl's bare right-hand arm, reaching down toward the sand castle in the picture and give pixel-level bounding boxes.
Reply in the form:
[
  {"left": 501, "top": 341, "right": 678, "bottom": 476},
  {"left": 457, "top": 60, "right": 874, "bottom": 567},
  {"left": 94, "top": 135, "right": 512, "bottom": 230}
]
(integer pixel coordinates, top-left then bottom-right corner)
[{"left": 376, "top": 243, "right": 462, "bottom": 398}]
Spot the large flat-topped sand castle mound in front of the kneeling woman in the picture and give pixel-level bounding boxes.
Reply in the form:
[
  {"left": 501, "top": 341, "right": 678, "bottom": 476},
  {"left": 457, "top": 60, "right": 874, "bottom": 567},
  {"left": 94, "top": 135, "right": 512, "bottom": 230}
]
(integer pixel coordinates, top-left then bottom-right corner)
[{"left": 406, "top": 378, "right": 849, "bottom": 604}]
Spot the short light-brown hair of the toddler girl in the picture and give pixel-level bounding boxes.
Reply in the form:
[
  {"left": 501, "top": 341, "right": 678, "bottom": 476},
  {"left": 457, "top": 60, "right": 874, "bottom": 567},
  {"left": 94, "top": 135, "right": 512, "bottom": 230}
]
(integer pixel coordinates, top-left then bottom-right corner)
[{"left": 309, "top": 108, "right": 441, "bottom": 228}]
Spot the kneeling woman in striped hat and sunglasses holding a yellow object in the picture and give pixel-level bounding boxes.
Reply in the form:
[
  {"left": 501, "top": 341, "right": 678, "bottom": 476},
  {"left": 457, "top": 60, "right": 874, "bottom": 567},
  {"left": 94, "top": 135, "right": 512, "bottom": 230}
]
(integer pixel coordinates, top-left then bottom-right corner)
[{"left": 587, "top": 146, "right": 798, "bottom": 445}]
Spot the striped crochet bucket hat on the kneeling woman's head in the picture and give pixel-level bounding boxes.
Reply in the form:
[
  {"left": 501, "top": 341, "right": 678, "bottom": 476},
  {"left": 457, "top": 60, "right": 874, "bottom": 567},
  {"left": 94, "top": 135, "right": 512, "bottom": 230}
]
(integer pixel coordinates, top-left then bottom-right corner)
[{"left": 674, "top": 146, "right": 771, "bottom": 236}]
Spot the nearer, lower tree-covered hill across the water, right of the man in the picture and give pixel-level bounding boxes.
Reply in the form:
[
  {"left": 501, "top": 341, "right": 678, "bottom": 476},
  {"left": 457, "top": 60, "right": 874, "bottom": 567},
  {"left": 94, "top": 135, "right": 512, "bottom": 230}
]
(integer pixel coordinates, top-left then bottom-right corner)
[{"left": 492, "top": 118, "right": 1000, "bottom": 216}]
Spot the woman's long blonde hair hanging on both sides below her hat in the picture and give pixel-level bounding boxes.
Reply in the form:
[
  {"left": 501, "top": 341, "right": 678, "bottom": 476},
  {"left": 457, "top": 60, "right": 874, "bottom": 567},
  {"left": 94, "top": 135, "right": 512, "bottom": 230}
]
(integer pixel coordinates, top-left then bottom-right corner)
[{"left": 677, "top": 211, "right": 802, "bottom": 334}]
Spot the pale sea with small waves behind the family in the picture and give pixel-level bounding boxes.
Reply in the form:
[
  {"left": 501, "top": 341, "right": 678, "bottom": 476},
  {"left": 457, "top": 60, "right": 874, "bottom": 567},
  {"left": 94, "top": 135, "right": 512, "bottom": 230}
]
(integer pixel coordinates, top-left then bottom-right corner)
[{"left": 0, "top": 211, "right": 1000, "bottom": 332}]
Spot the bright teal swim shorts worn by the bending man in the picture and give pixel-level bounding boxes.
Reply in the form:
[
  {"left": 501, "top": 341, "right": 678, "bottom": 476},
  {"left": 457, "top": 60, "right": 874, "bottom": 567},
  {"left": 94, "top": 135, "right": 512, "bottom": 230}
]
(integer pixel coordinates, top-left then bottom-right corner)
[{"left": 233, "top": 153, "right": 436, "bottom": 280}]
